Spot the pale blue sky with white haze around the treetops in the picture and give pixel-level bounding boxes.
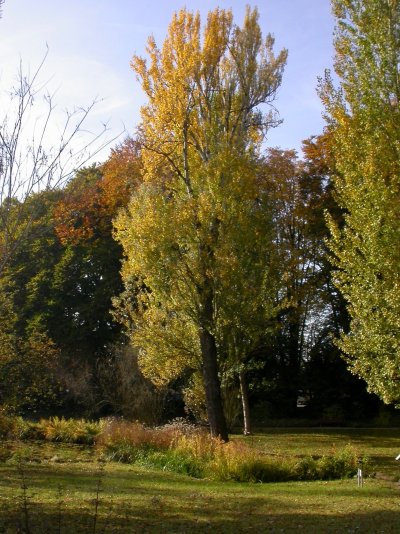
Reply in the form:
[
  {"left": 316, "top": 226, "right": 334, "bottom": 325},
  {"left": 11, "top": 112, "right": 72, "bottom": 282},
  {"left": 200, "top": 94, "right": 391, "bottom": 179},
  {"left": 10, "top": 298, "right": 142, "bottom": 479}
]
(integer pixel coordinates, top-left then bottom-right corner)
[{"left": 0, "top": 0, "right": 333, "bottom": 160}]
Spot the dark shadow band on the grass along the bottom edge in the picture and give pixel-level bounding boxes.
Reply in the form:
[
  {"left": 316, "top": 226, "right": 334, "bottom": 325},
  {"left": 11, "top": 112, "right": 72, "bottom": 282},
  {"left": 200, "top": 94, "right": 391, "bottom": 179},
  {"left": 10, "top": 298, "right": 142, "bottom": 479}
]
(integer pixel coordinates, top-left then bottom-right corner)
[{"left": 0, "top": 502, "right": 399, "bottom": 534}]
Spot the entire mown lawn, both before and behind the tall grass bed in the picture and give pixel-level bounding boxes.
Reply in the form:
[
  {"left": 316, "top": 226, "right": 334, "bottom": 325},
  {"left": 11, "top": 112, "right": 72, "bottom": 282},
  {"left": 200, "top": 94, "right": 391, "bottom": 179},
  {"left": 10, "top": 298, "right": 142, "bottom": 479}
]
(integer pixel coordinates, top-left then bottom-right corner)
[{"left": 0, "top": 429, "right": 400, "bottom": 534}]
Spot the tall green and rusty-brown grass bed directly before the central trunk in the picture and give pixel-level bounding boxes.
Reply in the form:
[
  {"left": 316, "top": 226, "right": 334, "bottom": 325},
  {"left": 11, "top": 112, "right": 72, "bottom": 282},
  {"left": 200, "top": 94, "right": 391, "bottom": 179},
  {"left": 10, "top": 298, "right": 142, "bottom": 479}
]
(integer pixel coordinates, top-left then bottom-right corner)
[{"left": 97, "top": 420, "right": 365, "bottom": 482}]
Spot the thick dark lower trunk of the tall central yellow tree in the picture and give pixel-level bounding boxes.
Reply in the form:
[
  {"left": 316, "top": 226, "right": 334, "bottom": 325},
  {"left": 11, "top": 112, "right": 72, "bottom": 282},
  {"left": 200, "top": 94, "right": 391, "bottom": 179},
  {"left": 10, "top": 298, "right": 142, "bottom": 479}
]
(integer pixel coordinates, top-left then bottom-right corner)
[{"left": 200, "top": 329, "right": 228, "bottom": 441}]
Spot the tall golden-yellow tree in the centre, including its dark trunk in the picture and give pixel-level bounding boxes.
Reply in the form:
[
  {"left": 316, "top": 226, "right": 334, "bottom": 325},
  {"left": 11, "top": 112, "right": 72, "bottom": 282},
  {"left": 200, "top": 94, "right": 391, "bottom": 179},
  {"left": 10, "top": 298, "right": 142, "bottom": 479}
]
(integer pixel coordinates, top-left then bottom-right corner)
[{"left": 116, "top": 9, "right": 287, "bottom": 440}]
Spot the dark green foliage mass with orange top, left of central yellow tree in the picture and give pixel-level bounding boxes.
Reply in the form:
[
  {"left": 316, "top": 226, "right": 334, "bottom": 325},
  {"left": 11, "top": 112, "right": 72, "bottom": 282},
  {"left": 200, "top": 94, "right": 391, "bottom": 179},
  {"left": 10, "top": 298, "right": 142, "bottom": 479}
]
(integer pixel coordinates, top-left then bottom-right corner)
[{"left": 0, "top": 167, "right": 131, "bottom": 415}]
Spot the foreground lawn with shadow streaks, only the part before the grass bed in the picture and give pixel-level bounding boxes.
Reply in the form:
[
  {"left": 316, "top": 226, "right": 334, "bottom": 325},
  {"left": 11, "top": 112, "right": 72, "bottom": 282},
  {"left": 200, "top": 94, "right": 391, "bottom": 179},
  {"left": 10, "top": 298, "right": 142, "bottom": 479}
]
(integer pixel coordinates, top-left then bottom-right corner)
[{"left": 0, "top": 465, "right": 399, "bottom": 534}]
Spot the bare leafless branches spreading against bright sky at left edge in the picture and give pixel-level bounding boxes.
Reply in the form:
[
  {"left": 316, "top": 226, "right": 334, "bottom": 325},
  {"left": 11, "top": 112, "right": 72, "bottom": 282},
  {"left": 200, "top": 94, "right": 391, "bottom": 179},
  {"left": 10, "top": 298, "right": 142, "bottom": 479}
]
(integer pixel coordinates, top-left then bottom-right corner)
[{"left": 0, "top": 53, "right": 123, "bottom": 274}]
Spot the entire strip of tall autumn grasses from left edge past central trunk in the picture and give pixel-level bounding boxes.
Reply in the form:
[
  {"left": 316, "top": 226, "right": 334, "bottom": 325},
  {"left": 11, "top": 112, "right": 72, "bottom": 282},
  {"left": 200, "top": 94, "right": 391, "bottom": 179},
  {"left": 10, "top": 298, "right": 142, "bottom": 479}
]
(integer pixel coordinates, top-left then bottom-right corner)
[{"left": 2, "top": 416, "right": 367, "bottom": 488}]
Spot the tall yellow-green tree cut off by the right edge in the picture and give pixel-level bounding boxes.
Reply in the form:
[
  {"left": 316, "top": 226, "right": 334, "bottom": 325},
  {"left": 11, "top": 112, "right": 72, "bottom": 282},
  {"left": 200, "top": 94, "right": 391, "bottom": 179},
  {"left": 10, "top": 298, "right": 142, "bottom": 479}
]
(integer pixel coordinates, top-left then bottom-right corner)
[{"left": 320, "top": 0, "right": 400, "bottom": 403}]
